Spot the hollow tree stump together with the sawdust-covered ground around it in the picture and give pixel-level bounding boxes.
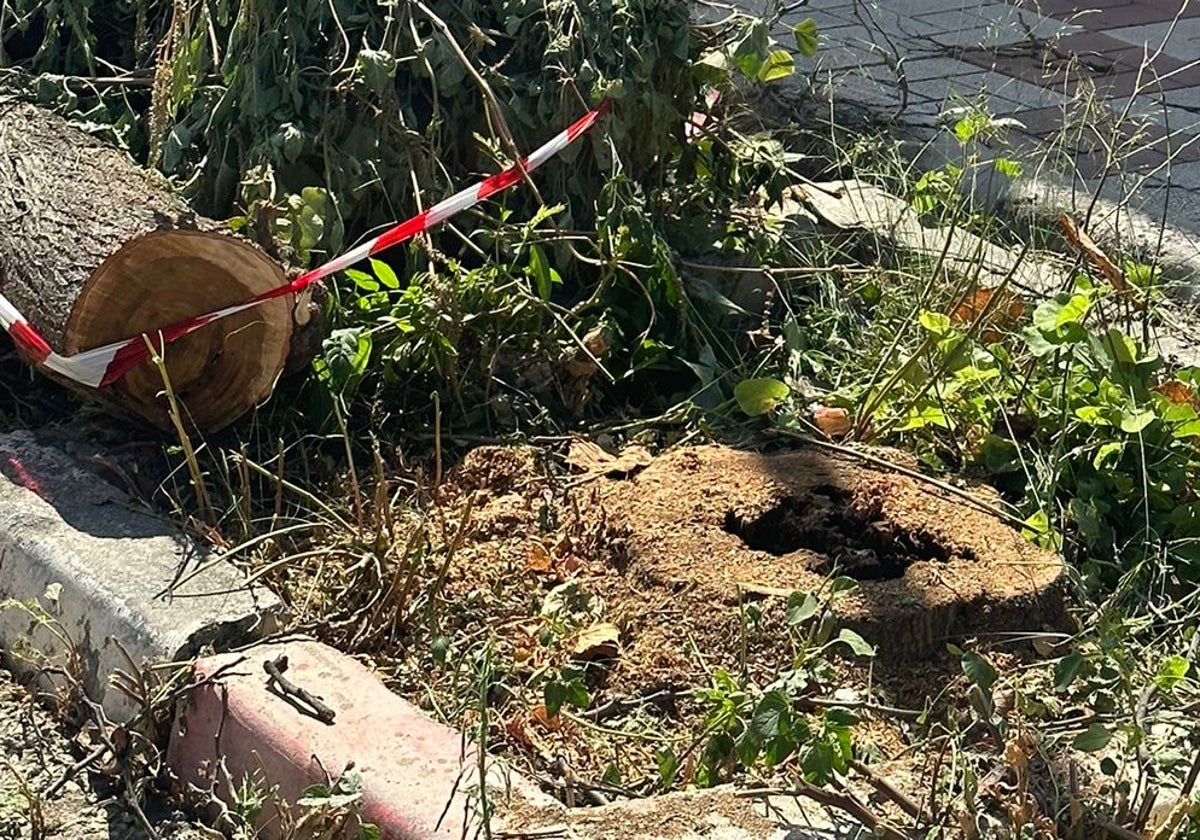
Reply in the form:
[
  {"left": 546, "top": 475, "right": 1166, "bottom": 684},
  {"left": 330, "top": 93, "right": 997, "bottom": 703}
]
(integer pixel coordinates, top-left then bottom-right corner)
[{"left": 417, "top": 446, "right": 1063, "bottom": 804}]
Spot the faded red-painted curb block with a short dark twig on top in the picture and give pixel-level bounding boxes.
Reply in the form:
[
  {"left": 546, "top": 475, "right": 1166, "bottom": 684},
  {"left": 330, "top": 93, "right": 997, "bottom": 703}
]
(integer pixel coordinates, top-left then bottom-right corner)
[{"left": 168, "top": 641, "right": 475, "bottom": 840}]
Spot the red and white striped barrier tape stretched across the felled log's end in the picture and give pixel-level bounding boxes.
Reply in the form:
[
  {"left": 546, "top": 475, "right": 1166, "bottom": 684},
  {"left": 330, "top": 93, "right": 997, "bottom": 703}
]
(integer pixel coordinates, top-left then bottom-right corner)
[{"left": 0, "top": 101, "right": 610, "bottom": 388}]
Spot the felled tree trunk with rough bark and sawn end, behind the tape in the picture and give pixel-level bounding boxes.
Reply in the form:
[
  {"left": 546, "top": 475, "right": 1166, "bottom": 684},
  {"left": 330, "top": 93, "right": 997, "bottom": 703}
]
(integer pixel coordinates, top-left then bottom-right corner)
[{"left": 0, "top": 103, "right": 312, "bottom": 431}]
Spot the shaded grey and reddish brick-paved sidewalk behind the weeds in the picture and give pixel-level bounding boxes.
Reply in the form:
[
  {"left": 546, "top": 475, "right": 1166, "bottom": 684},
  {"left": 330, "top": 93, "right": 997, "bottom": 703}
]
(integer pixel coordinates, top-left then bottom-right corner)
[{"left": 736, "top": 0, "right": 1200, "bottom": 291}]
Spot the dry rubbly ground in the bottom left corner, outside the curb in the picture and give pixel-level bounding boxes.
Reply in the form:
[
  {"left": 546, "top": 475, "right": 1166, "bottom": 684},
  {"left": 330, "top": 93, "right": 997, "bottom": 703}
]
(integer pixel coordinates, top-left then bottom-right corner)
[{"left": 0, "top": 670, "right": 208, "bottom": 840}]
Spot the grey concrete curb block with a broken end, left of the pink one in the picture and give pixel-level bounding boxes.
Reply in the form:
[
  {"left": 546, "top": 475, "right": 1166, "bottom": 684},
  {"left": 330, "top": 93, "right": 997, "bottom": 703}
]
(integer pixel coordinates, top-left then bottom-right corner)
[{"left": 0, "top": 432, "right": 282, "bottom": 719}]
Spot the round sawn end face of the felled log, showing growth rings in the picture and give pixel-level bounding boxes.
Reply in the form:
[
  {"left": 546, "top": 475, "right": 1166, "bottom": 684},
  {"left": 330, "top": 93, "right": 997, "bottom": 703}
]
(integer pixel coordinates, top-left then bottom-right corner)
[{"left": 64, "top": 230, "right": 293, "bottom": 431}]
